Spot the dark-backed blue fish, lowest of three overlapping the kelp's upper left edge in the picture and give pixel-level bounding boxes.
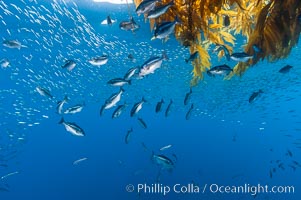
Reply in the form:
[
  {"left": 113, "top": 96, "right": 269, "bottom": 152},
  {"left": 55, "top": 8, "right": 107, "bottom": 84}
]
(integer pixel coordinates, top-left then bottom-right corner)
[{"left": 151, "top": 16, "right": 180, "bottom": 40}]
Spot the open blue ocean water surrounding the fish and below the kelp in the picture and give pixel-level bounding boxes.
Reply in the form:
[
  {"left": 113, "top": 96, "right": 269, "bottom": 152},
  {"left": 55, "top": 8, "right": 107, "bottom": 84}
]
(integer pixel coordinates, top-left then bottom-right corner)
[{"left": 0, "top": 0, "right": 301, "bottom": 200}]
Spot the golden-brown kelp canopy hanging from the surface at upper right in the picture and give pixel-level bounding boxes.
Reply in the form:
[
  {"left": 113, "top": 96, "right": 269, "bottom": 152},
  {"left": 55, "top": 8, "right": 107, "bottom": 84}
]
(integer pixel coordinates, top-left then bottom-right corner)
[{"left": 134, "top": 0, "right": 301, "bottom": 85}]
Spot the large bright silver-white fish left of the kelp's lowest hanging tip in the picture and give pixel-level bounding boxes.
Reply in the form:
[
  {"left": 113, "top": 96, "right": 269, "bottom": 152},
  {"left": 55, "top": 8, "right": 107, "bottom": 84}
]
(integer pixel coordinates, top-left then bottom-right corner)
[{"left": 138, "top": 53, "right": 167, "bottom": 78}]
